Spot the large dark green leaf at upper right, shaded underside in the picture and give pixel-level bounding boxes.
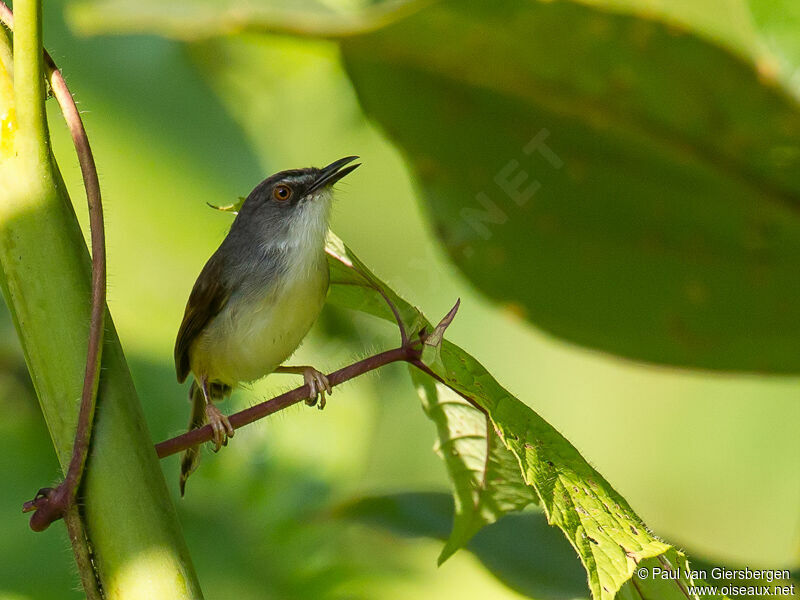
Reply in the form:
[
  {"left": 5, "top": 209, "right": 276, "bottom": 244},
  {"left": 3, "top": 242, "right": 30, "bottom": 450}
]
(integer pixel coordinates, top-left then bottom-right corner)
[{"left": 334, "top": 0, "right": 800, "bottom": 373}]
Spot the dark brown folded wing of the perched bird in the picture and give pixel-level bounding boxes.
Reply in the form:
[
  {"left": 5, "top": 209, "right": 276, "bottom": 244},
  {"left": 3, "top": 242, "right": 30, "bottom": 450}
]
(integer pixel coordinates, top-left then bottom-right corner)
[{"left": 175, "top": 256, "right": 230, "bottom": 383}]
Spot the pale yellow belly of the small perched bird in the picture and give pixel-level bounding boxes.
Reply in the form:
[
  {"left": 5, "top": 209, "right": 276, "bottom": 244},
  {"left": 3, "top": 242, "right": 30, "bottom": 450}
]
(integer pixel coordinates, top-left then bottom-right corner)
[{"left": 190, "top": 256, "right": 328, "bottom": 387}]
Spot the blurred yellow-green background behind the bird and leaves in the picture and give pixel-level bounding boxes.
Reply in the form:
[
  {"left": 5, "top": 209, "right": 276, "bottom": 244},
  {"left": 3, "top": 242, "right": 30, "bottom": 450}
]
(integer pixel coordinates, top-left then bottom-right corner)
[{"left": 0, "top": 1, "right": 800, "bottom": 600}]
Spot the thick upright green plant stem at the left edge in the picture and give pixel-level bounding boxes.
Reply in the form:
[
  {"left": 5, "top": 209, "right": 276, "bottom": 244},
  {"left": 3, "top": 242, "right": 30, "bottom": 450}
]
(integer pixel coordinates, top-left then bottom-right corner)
[{"left": 0, "top": 0, "right": 202, "bottom": 600}]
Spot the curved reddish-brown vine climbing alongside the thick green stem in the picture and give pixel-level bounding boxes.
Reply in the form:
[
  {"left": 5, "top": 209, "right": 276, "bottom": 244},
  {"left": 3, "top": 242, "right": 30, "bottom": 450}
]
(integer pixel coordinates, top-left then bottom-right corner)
[{"left": 0, "top": 1, "right": 106, "bottom": 531}]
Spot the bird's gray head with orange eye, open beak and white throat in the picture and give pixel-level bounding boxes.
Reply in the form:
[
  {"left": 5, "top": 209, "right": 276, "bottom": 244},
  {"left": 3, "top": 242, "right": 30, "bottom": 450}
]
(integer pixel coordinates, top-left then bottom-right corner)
[{"left": 231, "top": 156, "right": 360, "bottom": 252}]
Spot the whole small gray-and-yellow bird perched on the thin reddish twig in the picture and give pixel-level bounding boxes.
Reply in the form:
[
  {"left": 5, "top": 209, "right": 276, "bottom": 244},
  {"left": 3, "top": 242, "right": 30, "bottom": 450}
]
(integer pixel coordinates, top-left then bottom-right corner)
[{"left": 175, "top": 156, "right": 360, "bottom": 496}]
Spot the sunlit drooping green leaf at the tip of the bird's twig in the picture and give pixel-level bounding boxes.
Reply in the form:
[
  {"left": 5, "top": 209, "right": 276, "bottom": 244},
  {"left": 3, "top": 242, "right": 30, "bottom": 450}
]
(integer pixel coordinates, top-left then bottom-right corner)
[{"left": 327, "top": 234, "right": 692, "bottom": 600}]
